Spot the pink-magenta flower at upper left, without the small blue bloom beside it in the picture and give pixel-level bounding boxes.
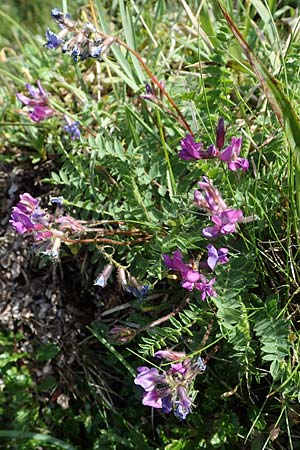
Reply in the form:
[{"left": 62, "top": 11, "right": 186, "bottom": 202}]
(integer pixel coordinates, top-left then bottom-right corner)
[{"left": 17, "top": 80, "right": 55, "bottom": 122}]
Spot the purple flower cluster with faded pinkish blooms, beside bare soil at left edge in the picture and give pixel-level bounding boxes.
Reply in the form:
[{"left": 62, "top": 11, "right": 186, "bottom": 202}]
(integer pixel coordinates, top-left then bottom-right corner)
[{"left": 9, "top": 193, "right": 85, "bottom": 259}]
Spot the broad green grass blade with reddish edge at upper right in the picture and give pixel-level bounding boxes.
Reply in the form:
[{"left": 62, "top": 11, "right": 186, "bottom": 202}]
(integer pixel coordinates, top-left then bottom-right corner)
[{"left": 218, "top": 1, "right": 300, "bottom": 170}]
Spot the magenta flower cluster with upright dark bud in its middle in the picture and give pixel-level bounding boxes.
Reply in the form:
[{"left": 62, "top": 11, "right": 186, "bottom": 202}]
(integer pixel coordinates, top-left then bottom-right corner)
[{"left": 178, "top": 118, "right": 249, "bottom": 172}]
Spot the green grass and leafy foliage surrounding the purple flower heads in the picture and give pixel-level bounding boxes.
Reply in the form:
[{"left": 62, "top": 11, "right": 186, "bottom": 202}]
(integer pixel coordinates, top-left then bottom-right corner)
[{"left": 0, "top": 0, "right": 300, "bottom": 450}]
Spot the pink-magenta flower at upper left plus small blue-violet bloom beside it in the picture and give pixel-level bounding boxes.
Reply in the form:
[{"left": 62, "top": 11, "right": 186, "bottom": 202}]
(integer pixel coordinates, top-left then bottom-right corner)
[{"left": 16, "top": 80, "right": 80, "bottom": 141}]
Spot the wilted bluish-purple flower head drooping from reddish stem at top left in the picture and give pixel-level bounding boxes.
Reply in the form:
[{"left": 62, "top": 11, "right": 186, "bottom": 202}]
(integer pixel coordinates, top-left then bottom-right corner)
[{"left": 45, "top": 8, "right": 115, "bottom": 62}]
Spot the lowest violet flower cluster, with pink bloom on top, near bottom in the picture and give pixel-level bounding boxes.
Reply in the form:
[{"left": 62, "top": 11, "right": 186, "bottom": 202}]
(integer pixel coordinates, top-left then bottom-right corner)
[{"left": 134, "top": 350, "right": 206, "bottom": 420}]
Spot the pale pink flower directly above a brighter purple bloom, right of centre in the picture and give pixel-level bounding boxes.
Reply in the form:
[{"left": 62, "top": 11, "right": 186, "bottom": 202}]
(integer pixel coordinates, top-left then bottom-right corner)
[{"left": 194, "top": 177, "right": 227, "bottom": 213}]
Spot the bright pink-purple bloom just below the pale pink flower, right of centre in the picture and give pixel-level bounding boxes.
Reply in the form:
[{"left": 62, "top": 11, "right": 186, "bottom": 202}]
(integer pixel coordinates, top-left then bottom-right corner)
[{"left": 202, "top": 209, "right": 243, "bottom": 238}]
